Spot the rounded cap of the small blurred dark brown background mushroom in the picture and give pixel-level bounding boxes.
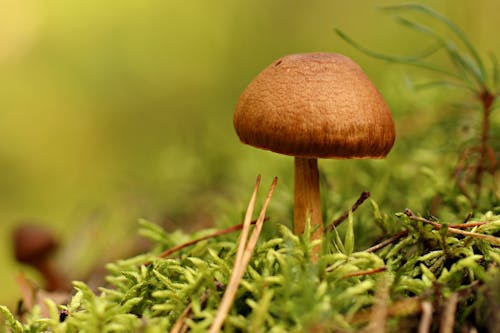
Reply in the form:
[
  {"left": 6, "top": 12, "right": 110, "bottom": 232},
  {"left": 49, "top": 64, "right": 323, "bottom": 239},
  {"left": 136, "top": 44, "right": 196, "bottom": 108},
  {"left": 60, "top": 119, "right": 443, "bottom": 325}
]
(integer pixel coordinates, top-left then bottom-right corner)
[{"left": 13, "top": 224, "right": 58, "bottom": 264}]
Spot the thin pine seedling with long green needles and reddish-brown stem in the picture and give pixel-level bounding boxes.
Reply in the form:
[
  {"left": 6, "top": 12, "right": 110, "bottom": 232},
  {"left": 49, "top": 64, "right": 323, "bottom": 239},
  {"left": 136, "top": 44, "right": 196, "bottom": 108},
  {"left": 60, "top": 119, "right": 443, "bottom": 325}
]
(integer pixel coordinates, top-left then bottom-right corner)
[{"left": 337, "top": 4, "right": 500, "bottom": 208}]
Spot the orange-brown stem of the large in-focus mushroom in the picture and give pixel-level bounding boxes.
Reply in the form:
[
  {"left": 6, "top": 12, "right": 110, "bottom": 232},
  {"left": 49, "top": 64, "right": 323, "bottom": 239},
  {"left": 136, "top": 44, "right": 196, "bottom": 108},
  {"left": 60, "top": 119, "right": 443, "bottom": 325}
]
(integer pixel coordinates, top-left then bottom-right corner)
[{"left": 293, "top": 157, "right": 323, "bottom": 240}]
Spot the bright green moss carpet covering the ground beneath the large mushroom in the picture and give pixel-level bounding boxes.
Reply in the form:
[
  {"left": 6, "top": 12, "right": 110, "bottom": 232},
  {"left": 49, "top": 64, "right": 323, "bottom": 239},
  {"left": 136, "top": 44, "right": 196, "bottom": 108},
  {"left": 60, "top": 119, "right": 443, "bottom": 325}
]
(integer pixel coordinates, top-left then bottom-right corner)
[{"left": 0, "top": 209, "right": 500, "bottom": 332}]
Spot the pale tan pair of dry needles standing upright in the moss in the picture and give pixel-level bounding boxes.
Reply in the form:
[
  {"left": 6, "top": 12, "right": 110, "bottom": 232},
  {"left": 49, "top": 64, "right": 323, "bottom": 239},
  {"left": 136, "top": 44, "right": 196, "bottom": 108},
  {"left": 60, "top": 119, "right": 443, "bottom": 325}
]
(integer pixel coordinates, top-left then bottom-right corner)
[{"left": 209, "top": 177, "right": 278, "bottom": 333}]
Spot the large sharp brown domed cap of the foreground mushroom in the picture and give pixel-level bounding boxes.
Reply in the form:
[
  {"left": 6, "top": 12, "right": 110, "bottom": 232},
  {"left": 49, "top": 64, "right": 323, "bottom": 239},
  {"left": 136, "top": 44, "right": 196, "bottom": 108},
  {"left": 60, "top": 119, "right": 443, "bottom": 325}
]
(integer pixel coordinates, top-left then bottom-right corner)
[{"left": 233, "top": 53, "right": 395, "bottom": 158}]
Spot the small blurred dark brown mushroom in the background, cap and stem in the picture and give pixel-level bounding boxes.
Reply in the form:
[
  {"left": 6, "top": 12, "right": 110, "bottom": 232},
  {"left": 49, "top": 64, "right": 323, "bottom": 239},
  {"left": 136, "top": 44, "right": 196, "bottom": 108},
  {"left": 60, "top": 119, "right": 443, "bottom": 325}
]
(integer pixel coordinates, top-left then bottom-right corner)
[{"left": 13, "top": 224, "right": 71, "bottom": 291}]
